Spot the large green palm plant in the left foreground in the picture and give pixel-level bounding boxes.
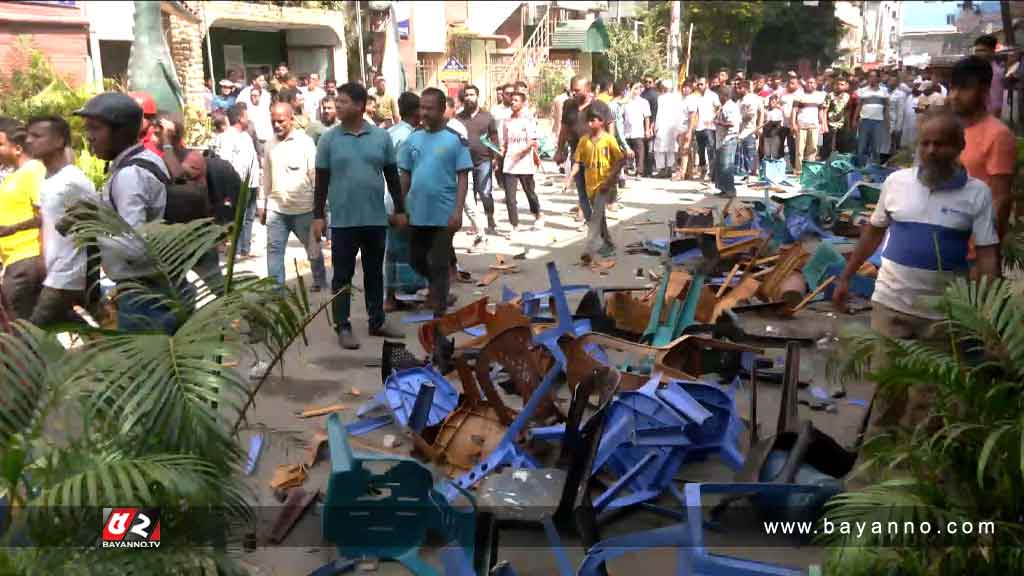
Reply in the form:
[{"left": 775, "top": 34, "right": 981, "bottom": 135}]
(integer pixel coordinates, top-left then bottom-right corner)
[{"left": 0, "top": 199, "right": 327, "bottom": 565}]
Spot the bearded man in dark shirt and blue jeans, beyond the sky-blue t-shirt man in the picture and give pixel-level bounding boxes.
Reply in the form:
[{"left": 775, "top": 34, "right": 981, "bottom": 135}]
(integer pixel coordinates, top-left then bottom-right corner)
[{"left": 456, "top": 84, "right": 498, "bottom": 236}]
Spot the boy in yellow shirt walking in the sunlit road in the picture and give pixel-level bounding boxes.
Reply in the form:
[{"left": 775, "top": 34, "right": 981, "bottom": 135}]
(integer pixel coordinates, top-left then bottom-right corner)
[{"left": 563, "top": 108, "right": 626, "bottom": 263}]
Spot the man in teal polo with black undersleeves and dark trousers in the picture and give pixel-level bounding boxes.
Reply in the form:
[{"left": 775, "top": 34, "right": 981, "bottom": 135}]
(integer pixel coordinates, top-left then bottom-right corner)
[{"left": 312, "top": 82, "right": 406, "bottom": 349}]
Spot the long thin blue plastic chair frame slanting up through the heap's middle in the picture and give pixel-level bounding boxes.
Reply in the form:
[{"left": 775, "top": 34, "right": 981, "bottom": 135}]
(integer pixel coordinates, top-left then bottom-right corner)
[{"left": 444, "top": 262, "right": 573, "bottom": 499}]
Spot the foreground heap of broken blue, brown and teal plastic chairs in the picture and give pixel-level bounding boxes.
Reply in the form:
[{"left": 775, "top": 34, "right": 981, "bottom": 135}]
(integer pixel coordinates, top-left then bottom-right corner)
[{"left": 323, "top": 261, "right": 853, "bottom": 576}]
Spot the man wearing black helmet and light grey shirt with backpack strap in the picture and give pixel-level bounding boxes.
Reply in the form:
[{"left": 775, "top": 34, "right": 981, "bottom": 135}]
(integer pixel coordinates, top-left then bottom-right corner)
[{"left": 75, "top": 92, "right": 175, "bottom": 333}]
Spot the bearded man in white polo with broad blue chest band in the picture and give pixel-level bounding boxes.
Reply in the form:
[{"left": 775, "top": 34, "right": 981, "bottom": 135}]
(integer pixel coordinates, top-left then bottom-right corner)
[{"left": 833, "top": 110, "right": 999, "bottom": 436}]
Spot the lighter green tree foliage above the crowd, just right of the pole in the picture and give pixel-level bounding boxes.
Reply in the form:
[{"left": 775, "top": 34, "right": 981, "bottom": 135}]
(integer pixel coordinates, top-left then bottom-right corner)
[{"left": 684, "top": 0, "right": 774, "bottom": 74}]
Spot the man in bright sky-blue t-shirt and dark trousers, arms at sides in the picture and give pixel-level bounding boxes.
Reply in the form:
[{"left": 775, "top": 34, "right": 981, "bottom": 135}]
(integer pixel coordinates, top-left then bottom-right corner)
[{"left": 398, "top": 88, "right": 473, "bottom": 318}]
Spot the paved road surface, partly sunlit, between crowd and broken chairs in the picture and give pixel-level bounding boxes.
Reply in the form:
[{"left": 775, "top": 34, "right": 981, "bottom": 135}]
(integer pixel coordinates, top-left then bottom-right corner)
[{"left": 234, "top": 164, "right": 870, "bottom": 576}]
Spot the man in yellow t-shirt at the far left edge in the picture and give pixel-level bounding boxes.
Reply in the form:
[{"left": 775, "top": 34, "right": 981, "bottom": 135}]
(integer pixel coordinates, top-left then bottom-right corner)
[{"left": 0, "top": 118, "right": 46, "bottom": 320}]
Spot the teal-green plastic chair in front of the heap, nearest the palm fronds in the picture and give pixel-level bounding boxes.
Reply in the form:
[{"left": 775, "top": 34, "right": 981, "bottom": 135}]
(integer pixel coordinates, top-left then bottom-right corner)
[{"left": 322, "top": 414, "right": 476, "bottom": 576}]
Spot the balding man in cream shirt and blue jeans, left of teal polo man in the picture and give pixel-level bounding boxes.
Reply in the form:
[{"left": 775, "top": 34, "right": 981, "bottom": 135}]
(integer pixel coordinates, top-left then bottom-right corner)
[{"left": 256, "top": 102, "right": 327, "bottom": 292}]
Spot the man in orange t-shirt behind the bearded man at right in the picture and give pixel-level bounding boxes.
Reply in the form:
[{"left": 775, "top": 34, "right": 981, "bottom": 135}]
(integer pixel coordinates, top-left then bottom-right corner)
[{"left": 948, "top": 56, "right": 1017, "bottom": 239}]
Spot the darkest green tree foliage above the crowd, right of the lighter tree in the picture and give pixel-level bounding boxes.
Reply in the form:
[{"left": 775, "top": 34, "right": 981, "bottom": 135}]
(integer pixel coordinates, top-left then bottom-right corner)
[{"left": 751, "top": 1, "right": 843, "bottom": 72}]
